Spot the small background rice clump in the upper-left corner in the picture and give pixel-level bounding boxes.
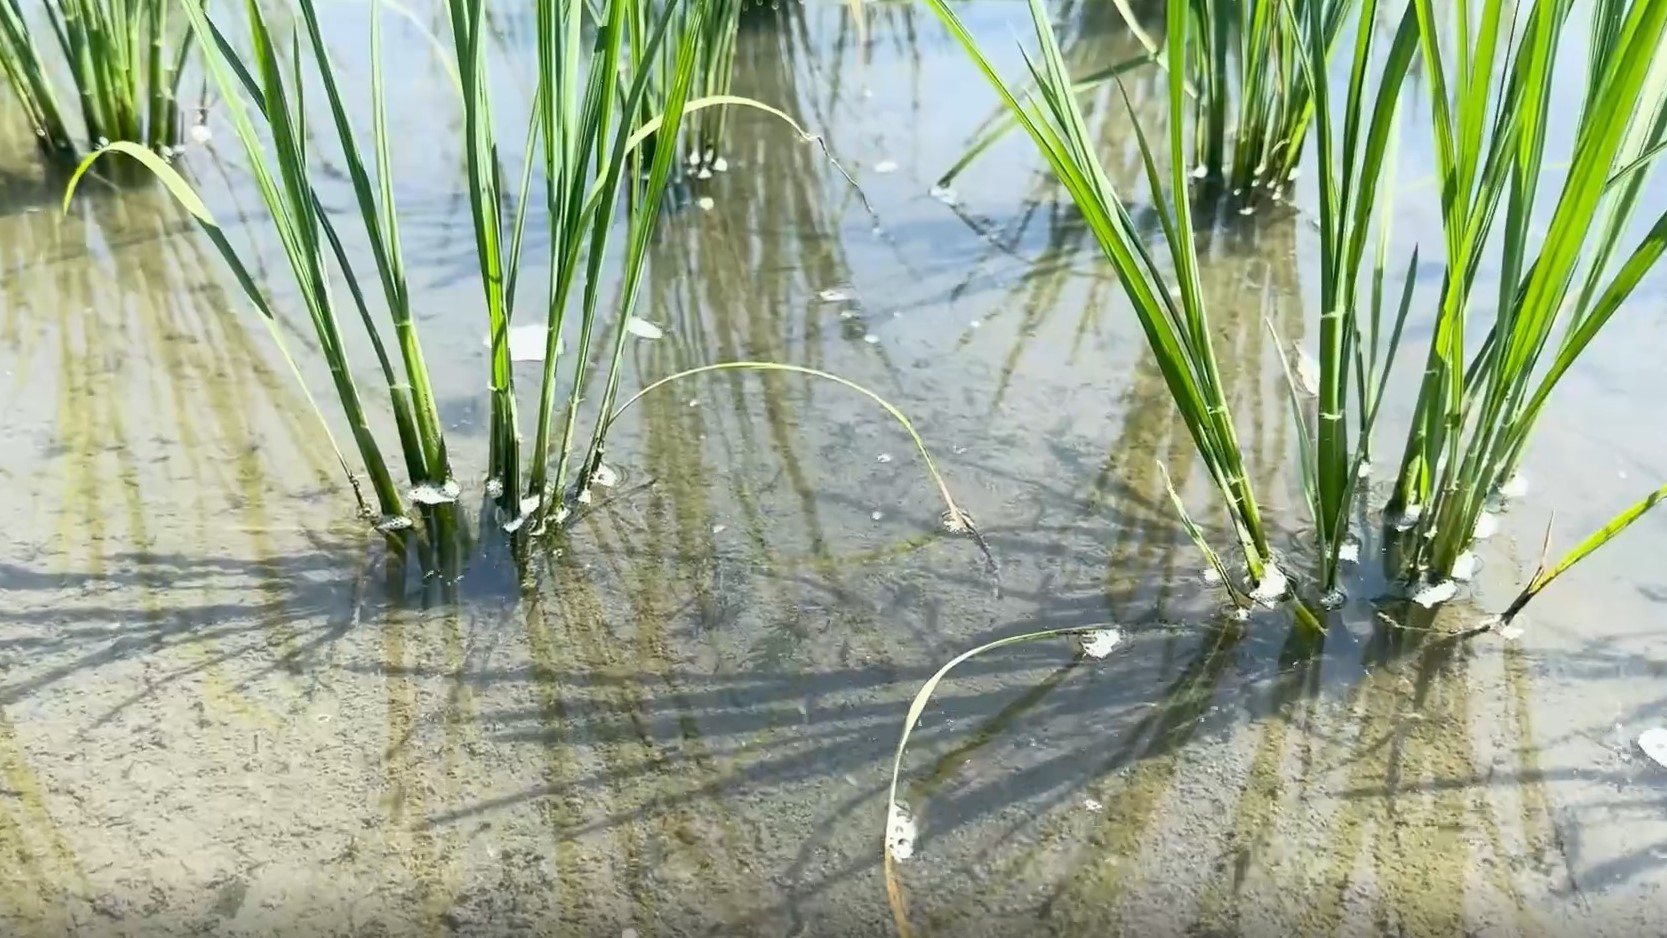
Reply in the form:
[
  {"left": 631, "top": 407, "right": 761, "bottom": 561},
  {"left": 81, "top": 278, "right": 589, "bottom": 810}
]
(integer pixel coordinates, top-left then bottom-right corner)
[{"left": 0, "top": 0, "right": 197, "bottom": 167}]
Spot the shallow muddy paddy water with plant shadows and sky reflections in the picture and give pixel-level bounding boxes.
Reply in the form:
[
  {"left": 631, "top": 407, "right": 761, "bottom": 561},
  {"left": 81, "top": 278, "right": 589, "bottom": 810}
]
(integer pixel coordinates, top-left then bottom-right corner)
[{"left": 0, "top": 0, "right": 1667, "bottom": 938}]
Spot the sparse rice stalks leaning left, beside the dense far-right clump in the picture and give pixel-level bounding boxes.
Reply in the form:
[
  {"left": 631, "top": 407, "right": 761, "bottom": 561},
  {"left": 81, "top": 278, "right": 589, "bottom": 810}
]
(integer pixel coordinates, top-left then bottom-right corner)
[{"left": 932, "top": 0, "right": 1415, "bottom": 621}]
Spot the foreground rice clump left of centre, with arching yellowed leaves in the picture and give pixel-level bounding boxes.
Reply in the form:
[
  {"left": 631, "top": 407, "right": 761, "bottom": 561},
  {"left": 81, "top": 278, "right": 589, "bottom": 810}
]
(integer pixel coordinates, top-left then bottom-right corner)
[{"left": 65, "top": 0, "right": 964, "bottom": 576}]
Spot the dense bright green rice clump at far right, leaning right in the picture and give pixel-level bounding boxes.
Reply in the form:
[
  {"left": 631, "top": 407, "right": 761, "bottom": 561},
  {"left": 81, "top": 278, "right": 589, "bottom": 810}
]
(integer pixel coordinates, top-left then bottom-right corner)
[{"left": 1389, "top": 0, "right": 1667, "bottom": 596}]
